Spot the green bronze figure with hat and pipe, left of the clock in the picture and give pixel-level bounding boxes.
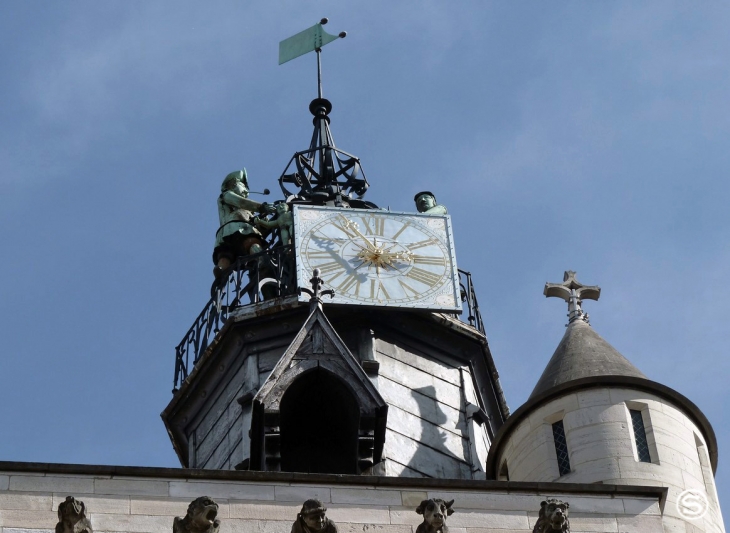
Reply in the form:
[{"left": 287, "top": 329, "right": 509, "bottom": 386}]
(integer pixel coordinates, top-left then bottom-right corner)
[{"left": 213, "top": 168, "right": 267, "bottom": 277}]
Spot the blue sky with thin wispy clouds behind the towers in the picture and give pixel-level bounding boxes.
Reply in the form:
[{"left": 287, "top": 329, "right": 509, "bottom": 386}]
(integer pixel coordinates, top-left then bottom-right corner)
[{"left": 0, "top": 1, "right": 730, "bottom": 510}]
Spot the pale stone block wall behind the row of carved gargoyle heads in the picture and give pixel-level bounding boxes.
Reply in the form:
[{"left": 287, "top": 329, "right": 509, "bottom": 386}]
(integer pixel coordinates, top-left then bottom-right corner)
[{"left": 0, "top": 463, "right": 665, "bottom": 533}]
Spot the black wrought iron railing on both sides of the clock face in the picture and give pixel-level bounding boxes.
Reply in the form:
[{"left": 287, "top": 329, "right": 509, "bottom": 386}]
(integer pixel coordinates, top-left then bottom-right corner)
[{"left": 172, "top": 256, "right": 485, "bottom": 393}]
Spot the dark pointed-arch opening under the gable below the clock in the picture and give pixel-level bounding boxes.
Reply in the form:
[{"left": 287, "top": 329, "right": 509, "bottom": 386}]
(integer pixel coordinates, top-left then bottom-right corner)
[{"left": 280, "top": 368, "right": 360, "bottom": 474}]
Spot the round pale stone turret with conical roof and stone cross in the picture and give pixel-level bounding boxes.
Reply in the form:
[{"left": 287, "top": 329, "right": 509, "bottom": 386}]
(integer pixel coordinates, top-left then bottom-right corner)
[{"left": 487, "top": 272, "right": 725, "bottom": 533}]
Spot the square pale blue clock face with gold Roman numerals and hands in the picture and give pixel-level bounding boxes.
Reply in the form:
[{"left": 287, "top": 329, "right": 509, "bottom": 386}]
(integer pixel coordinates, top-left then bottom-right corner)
[{"left": 294, "top": 206, "right": 461, "bottom": 312}]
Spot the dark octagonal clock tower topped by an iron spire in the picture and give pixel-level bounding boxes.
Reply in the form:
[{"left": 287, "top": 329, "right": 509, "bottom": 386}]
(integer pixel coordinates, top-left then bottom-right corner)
[{"left": 162, "top": 28, "right": 509, "bottom": 479}]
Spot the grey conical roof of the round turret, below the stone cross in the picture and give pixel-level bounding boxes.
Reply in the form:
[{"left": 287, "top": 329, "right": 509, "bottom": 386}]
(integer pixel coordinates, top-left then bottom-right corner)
[{"left": 530, "top": 320, "right": 646, "bottom": 398}]
